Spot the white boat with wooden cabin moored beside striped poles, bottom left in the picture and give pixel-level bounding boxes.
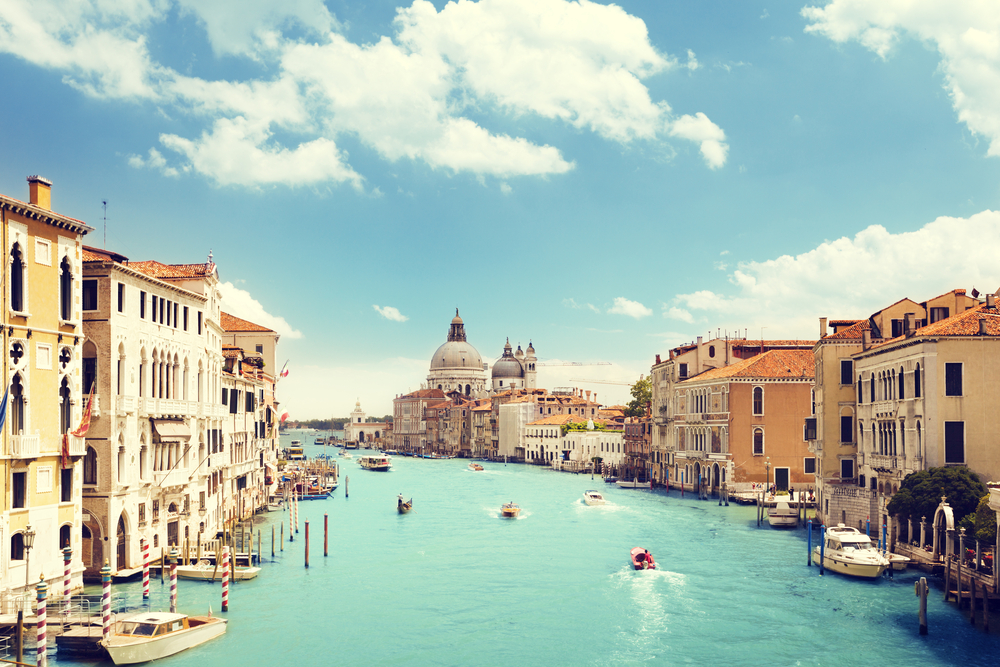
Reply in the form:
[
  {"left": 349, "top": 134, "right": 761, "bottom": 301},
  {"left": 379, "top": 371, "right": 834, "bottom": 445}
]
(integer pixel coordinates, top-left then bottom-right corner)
[{"left": 101, "top": 612, "right": 227, "bottom": 665}]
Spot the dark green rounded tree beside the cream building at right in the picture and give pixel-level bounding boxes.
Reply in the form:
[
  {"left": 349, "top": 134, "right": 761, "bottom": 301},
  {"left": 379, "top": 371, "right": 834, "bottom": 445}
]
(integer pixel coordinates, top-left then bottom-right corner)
[{"left": 886, "top": 466, "right": 987, "bottom": 526}]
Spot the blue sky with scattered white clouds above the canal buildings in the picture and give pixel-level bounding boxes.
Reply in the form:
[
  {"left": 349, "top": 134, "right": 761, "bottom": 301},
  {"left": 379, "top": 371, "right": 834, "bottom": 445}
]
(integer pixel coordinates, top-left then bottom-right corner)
[{"left": 0, "top": 0, "right": 1000, "bottom": 419}]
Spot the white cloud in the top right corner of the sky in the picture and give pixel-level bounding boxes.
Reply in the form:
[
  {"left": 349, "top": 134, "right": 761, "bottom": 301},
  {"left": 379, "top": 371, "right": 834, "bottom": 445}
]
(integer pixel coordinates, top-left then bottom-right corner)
[{"left": 802, "top": 0, "right": 1000, "bottom": 156}]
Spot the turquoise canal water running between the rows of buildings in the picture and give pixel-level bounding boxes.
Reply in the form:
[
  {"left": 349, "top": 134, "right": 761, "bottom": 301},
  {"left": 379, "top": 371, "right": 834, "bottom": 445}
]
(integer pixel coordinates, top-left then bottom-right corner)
[{"left": 60, "top": 457, "right": 997, "bottom": 667}]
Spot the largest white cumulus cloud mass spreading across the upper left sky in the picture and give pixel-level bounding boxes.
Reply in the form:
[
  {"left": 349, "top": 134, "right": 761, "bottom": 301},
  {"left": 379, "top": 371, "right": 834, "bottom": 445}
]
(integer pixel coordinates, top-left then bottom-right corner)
[{"left": 0, "top": 0, "right": 728, "bottom": 187}]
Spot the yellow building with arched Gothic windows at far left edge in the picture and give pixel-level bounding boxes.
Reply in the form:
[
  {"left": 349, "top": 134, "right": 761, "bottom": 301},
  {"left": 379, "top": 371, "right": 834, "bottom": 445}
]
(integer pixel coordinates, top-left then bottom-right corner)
[{"left": 0, "top": 176, "right": 93, "bottom": 595}]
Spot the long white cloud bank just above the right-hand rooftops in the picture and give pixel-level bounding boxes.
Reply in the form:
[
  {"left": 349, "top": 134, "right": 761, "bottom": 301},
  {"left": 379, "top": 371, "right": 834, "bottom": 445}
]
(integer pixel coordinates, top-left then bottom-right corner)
[{"left": 665, "top": 211, "right": 1000, "bottom": 338}]
